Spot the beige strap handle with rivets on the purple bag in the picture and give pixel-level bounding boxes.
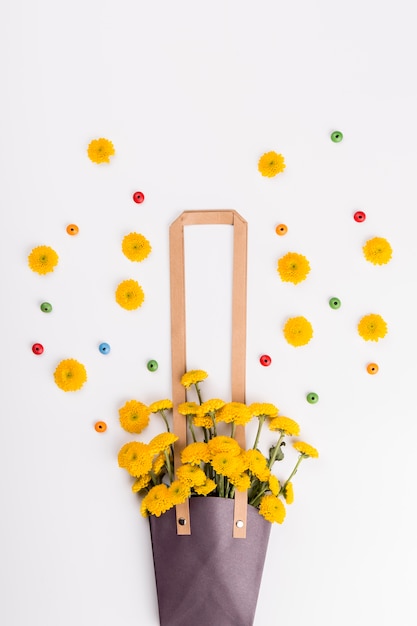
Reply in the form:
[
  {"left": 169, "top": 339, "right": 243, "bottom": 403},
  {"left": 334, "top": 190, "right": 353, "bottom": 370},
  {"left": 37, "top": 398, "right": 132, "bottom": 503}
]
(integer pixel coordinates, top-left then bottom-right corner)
[{"left": 169, "top": 210, "right": 248, "bottom": 539}]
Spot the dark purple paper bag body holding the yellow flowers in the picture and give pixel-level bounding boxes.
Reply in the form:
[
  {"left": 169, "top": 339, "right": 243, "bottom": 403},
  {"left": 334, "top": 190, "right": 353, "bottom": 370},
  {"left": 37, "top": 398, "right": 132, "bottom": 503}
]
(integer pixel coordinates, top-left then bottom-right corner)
[{"left": 149, "top": 496, "right": 271, "bottom": 626}]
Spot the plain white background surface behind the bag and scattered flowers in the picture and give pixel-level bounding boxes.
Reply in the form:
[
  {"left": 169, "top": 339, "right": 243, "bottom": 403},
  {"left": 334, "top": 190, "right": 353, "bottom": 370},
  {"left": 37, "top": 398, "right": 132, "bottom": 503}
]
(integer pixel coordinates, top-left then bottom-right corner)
[{"left": 0, "top": 0, "right": 417, "bottom": 626}]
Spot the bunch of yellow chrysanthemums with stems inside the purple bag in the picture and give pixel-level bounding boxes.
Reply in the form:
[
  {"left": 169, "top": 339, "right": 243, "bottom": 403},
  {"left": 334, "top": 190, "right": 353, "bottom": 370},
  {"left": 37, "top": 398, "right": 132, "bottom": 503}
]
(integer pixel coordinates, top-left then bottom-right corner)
[{"left": 118, "top": 370, "right": 318, "bottom": 524}]
